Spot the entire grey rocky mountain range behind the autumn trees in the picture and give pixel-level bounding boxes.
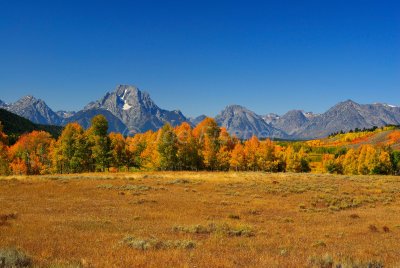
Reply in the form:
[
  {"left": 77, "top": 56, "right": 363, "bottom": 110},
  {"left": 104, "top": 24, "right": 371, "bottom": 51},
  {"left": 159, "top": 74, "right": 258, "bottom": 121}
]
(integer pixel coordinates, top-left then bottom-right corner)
[{"left": 0, "top": 85, "right": 400, "bottom": 139}]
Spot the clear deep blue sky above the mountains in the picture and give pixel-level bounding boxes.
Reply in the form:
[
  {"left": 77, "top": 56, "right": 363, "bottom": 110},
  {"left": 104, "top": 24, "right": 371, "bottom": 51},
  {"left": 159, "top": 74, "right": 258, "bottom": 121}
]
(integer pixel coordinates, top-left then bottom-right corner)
[{"left": 0, "top": 0, "right": 400, "bottom": 116}]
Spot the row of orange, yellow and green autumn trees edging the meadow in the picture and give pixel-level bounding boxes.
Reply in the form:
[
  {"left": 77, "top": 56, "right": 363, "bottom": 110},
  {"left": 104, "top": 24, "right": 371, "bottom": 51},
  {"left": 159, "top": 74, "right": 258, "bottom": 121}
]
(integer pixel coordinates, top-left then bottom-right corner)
[{"left": 0, "top": 115, "right": 393, "bottom": 175}]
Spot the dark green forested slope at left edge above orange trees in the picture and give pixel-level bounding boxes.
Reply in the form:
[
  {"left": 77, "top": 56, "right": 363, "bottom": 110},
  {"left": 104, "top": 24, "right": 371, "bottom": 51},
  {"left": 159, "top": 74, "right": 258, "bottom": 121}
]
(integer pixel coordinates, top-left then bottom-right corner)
[{"left": 0, "top": 108, "right": 63, "bottom": 143}]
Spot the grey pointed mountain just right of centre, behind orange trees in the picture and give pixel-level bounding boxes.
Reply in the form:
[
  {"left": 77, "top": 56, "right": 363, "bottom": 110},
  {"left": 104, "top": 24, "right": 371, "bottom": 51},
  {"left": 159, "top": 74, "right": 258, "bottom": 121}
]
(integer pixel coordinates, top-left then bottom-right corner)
[{"left": 215, "top": 105, "right": 289, "bottom": 139}]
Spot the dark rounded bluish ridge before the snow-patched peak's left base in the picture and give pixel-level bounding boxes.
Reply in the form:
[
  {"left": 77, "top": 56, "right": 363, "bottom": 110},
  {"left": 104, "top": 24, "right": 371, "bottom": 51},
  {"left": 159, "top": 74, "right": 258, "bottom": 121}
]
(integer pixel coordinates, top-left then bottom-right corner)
[{"left": 63, "top": 109, "right": 129, "bottom": 135}]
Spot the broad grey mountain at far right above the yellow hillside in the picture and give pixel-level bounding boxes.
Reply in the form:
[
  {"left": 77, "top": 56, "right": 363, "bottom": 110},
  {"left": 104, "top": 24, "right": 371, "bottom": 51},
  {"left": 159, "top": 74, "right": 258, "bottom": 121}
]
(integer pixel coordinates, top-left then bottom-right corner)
[{"left": 293, "top": 100, "right": 400, "bottom": 139}]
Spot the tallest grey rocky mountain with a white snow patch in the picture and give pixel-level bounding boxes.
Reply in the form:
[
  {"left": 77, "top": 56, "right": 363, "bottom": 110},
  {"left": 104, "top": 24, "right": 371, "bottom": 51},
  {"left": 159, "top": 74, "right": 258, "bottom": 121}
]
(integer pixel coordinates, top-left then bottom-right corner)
[{"left": 84, "top": 85, "right": 188, "bottom": 133}]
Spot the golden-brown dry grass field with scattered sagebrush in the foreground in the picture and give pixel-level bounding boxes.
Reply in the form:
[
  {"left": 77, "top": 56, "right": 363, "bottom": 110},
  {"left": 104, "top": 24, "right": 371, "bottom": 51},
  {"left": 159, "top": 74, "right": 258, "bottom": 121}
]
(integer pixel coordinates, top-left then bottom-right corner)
[{"left": 0, "top": 172, "right": 400, "bottom": 267}]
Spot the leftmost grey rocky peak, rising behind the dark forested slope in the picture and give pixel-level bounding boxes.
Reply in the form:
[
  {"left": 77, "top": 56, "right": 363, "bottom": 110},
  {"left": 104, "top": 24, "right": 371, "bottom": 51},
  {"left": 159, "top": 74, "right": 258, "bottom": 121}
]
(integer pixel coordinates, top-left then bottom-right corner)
[{"left": 5, "top": 96, "right": 61, "bottom": 125}]
